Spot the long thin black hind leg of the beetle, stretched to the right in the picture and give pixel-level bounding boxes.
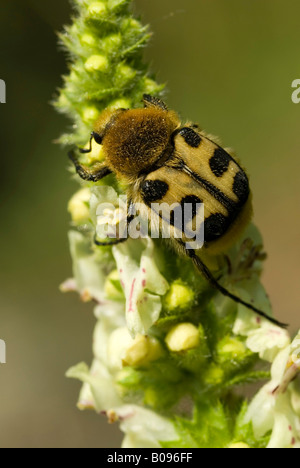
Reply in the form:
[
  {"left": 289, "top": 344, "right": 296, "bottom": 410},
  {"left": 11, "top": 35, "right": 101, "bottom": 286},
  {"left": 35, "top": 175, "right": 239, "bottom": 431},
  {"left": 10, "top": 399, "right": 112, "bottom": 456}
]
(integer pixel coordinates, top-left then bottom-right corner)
[{"left": 185, "top": 249, "right": 288, "bottom": 328}]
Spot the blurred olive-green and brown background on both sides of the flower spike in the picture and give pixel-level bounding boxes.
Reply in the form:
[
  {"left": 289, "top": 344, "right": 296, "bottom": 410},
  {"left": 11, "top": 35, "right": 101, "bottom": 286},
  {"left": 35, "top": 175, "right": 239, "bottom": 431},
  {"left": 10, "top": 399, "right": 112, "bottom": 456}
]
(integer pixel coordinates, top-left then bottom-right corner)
[{"left": 0, "top": 0, "right": 300, "bottom": 447}]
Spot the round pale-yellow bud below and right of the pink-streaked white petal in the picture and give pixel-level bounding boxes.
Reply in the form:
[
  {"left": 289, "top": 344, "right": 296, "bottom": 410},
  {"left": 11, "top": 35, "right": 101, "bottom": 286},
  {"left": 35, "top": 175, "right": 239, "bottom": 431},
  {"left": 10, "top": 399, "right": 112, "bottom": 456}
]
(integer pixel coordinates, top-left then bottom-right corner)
[{"left": 165, "top": 323, "right": 200, "bottom": 352}]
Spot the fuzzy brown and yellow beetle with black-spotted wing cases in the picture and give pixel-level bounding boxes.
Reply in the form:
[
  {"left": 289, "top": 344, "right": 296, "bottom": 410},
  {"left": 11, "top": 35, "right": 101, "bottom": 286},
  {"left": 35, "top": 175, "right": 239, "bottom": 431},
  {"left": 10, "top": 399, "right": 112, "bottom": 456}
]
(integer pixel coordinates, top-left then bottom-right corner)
[{"left": 69, "top": 94, "right": 285, "bottom": 326}]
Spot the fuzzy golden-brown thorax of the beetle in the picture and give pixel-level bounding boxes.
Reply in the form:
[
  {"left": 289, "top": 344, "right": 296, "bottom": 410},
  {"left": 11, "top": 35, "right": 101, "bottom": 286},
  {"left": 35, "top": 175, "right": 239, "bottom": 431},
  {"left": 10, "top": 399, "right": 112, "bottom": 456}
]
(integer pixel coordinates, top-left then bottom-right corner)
[{"left": 94, "top": 107, "right": 180, "bottom": 178}]
